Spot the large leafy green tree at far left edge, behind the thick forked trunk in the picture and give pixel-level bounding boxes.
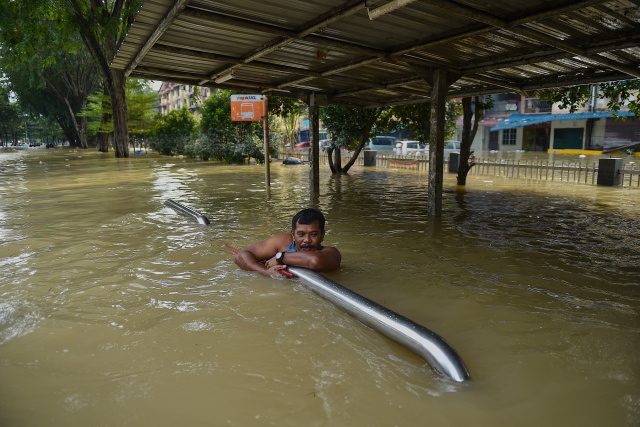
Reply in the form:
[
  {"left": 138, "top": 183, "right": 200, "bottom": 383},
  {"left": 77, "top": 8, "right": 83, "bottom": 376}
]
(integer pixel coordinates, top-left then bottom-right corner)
[{"left": 0, "top": 0, "right": 100, "bottom": 148}]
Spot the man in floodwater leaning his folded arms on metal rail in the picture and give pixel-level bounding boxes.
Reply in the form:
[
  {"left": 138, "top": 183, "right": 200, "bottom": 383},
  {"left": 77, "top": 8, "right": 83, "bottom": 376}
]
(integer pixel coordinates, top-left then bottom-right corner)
[{"left": 235, "top": 208, "right": 342, "bottom": 277}]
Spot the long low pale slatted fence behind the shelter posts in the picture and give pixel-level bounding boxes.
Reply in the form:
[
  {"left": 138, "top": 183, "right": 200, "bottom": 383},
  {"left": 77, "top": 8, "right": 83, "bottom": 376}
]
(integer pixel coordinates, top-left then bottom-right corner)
[{"left": 308, "top": 152, "right": 640, "bottom": 188}]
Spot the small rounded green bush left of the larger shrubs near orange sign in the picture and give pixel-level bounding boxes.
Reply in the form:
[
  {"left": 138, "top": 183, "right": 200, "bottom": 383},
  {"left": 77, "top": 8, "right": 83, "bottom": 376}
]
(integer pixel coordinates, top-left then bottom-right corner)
[{"left": 149, "top": 108, "right": 198, "bottom": 156}]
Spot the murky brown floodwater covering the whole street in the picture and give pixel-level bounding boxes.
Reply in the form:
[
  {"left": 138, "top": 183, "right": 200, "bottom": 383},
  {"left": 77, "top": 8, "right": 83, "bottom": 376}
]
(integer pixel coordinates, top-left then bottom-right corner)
[{"left": 0, "top": 148, "right": 640, "bottom": 427}]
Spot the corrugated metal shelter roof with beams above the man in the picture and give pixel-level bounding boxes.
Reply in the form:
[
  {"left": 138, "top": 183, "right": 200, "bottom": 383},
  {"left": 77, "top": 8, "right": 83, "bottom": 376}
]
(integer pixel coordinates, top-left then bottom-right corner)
[{"left": 112, "top": 0, "right": 640, "bottom": 107}]
